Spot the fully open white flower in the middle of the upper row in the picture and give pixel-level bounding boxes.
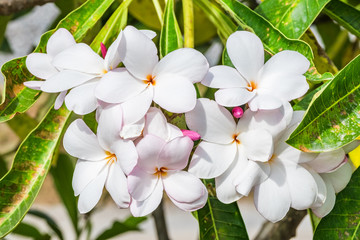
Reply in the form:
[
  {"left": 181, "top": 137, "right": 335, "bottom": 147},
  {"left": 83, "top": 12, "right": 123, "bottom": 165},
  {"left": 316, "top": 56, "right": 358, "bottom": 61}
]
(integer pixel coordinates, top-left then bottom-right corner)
[{"left": 96, "top": 26, "right": 209, "bottom": 124}]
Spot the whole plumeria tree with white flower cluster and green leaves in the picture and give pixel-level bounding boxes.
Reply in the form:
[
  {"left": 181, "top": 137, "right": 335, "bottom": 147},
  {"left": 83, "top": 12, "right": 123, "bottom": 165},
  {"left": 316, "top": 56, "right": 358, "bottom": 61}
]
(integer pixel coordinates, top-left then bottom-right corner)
[{"left": 0, "top": 0, "right": 360, "bottom": 240}]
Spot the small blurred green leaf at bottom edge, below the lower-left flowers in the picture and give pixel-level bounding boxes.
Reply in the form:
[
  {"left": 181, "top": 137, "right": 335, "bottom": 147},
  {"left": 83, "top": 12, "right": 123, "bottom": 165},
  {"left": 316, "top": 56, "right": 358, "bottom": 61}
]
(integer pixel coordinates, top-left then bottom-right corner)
[{"left": 96, "top": 217, "right": 147, "bottom": 240}]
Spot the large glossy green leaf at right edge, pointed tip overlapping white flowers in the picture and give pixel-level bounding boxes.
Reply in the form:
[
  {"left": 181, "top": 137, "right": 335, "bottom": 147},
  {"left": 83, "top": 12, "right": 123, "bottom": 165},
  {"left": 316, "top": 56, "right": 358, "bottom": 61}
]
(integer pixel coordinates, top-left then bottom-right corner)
[{"left": 286, "top": 56, "right": 360, "bottom": 152}]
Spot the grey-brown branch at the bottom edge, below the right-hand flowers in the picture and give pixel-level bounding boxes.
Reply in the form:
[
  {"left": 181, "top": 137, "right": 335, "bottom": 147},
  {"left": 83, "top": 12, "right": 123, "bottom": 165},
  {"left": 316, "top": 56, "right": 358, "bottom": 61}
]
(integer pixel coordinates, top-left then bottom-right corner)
[{"left": 255, "top": 208, "right": 307, "bottom": 240}]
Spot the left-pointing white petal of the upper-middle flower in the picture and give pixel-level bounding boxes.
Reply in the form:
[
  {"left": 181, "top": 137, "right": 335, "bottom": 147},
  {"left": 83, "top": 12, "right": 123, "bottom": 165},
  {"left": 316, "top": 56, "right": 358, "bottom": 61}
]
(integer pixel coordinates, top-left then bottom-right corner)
[{"left": 96, "top": 68, "right": 147, "bottom": 103}]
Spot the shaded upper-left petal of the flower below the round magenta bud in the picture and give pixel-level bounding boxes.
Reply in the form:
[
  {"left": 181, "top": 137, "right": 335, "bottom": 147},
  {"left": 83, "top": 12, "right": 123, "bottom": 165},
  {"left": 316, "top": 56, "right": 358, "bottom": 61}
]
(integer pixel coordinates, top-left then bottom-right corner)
[{"left": 185, "top": 98, "right": 236, "bottom": 144}]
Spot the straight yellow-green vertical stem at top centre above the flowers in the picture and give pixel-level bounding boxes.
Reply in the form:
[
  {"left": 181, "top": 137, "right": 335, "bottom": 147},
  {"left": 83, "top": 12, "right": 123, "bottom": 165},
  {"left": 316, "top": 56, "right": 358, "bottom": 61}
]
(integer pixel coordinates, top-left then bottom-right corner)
[{"left": 183, "top": 0, "right": 194, "bottom": 48}]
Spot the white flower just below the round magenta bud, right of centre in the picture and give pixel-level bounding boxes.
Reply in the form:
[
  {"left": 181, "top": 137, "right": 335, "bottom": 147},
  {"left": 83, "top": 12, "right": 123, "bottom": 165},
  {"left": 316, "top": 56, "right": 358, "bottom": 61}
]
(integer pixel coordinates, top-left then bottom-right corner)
[{"left": 185, "top": 98, "right": 273, "bottom": 203}]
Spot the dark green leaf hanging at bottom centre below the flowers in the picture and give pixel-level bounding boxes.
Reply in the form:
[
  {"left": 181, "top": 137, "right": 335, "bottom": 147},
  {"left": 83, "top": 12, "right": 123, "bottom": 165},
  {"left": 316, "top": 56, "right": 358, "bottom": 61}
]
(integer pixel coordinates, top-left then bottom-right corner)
[{"left": 195, "top": 180, "right": 249, "bottom": 240}]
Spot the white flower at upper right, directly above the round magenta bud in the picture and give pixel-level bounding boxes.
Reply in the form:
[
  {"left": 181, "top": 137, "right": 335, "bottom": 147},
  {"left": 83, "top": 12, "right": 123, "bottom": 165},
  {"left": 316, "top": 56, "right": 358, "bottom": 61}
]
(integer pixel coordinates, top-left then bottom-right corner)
[{"left": 201, "top": 31, "right": 310, "bottom": 111}]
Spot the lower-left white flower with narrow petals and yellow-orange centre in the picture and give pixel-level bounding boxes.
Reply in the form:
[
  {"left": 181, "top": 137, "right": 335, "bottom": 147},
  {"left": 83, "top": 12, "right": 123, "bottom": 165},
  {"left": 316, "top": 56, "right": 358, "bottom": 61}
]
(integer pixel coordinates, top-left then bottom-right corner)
[{"left": 64, "top": 106, "right": 138, "bottom": 213}]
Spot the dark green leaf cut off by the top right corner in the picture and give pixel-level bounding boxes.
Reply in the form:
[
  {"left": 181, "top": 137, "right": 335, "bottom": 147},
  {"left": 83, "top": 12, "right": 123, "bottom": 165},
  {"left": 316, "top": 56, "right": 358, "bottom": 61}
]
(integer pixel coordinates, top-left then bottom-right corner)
[{"left": 324, "top": 0, "right": 360, "bottom": 38}]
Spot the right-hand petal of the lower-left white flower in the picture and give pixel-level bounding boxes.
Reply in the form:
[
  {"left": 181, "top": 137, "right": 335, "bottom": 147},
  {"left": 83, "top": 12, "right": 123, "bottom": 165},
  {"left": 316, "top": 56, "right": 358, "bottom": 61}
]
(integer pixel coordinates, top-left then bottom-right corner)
[{"left": 110, "top": 139, "right": 138, "bottom": 175}]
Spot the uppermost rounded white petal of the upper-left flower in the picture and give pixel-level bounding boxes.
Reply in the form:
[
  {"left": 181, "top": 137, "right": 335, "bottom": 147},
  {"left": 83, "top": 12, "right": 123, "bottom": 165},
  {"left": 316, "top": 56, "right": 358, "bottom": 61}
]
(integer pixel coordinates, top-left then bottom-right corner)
[{"left": 46, "top": 28, "right": 76, "bottom": 58}]
